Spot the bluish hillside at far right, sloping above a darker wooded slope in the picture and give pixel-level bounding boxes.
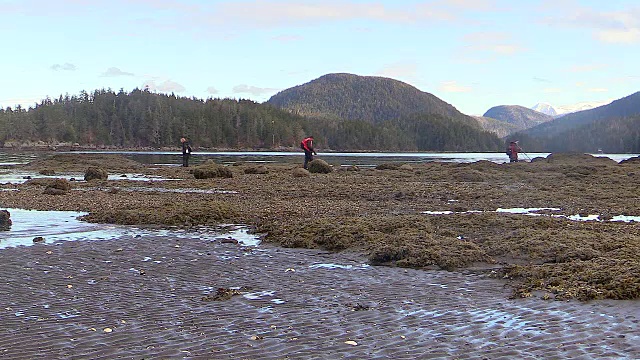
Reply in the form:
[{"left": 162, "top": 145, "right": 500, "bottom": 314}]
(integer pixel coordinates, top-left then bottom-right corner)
[{"left": 521, "top": 92, "right": 640, "bottom": 137}]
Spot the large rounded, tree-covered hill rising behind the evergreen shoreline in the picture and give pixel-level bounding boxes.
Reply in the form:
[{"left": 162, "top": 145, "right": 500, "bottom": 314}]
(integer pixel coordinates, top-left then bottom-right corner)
[{"left": 268, "top": 74, "right": 477, "bottom": 126}]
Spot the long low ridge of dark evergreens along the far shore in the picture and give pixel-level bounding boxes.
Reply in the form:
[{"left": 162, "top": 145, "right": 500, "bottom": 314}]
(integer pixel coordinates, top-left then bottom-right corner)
[{"left": 0, "top": 89, "right": 502, "bottom": 151}]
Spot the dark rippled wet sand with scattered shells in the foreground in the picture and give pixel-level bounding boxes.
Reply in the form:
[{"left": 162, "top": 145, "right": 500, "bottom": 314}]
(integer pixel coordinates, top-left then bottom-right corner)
[{"left": 0, "top": 236, "right": 640, "bottom": 359}]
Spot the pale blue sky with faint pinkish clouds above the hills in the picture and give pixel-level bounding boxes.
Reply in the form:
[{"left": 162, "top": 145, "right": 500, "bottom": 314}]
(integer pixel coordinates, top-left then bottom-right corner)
[{"left": 0, "top": 0, "right": 640, "bottom": 115}]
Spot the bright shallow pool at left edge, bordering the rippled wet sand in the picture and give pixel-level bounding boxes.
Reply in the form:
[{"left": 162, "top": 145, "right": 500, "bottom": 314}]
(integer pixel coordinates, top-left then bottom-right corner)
[{"left": 0, "top": 209, "right": 260, "bottom": 249}]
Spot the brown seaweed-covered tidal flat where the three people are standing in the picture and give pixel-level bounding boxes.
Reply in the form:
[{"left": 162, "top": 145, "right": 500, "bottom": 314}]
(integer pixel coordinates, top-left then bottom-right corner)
[{"left": 0, "top": 154, "right": 640, "bottom": 300}]
